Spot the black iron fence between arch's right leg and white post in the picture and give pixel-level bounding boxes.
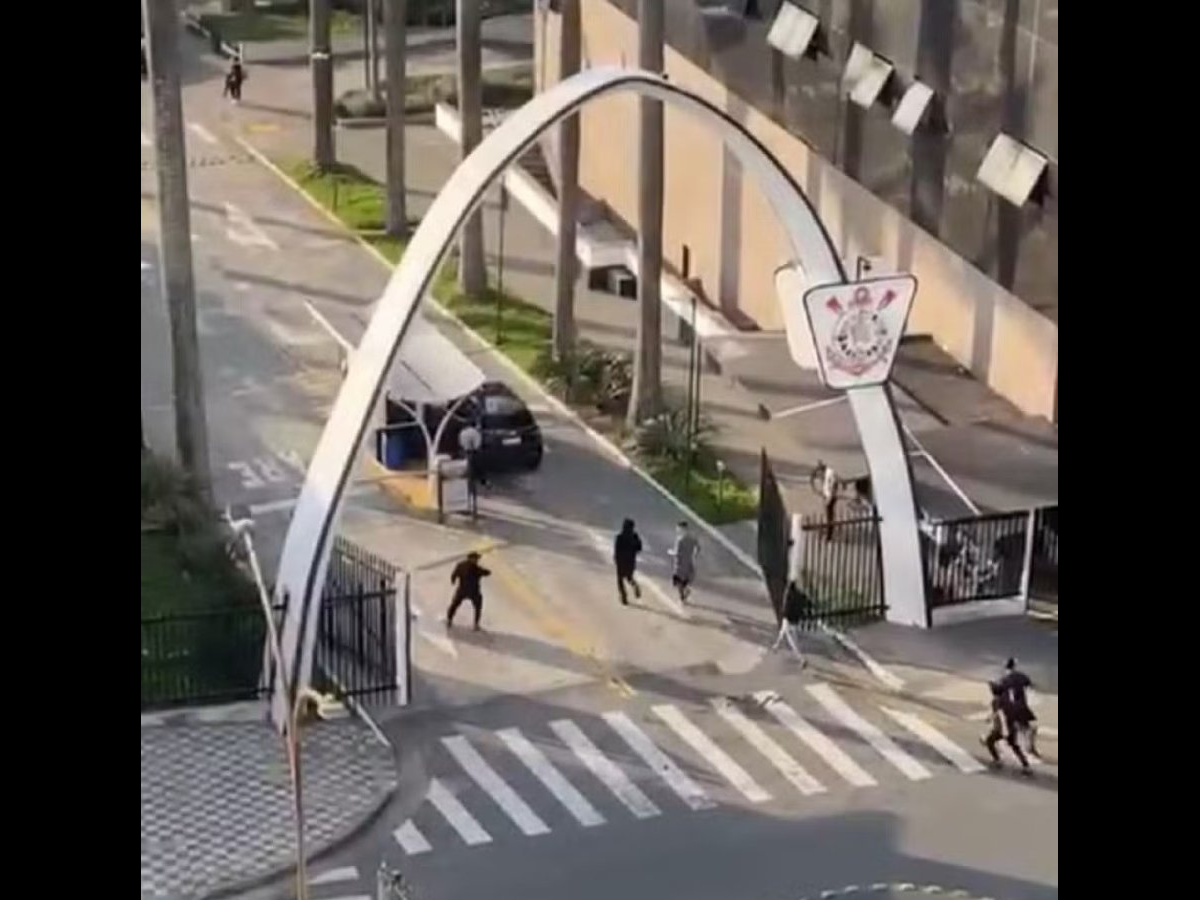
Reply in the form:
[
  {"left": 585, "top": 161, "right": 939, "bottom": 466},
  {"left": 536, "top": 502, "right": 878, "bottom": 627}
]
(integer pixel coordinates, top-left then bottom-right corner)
[{"left": 920, "top": 510, "right": 1030, "bottom": 608}]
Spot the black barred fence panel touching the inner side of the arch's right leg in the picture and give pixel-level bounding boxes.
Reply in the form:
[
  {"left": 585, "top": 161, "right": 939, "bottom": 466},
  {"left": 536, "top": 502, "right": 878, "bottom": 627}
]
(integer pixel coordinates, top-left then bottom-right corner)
[{"left": 798, "top": 516, "right": 887, "bottom": 628}]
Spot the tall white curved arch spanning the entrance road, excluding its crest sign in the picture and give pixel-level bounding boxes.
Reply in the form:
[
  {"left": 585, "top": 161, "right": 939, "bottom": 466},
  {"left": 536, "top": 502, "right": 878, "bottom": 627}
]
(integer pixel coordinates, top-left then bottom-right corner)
[{"left": 275, "top": 67, "right": 924, "bottom": 712}]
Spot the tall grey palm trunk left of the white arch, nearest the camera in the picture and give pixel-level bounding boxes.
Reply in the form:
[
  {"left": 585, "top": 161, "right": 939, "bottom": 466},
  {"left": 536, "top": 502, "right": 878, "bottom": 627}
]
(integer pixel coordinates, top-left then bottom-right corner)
[{"left": 142, "top": 0, "right": 211, "bottom": 499}]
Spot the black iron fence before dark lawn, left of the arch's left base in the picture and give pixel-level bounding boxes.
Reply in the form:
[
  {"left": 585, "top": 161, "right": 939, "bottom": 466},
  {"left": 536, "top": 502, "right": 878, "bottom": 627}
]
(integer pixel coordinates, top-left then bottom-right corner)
[{"left": 142, "top": 604, "right": 284, "bottom": 710}]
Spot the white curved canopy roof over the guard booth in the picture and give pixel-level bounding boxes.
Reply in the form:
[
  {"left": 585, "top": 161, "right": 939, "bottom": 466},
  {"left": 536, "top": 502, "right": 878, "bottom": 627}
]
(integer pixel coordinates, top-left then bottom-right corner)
[{"left": 388, "top": 314, "right": 487, "bottom": 403}]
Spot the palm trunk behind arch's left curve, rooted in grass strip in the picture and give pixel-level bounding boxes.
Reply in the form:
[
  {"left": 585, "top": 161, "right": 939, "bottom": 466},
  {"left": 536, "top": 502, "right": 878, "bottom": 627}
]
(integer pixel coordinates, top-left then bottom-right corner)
[{"left": 455, "top": 0, "right": 487, "bottom": 296}]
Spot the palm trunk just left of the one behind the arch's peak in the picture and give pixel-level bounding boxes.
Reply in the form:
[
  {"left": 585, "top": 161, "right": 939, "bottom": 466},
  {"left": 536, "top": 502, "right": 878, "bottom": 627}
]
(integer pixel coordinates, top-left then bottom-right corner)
[{"left": 553, "top": 0, "right": 581, "bottom": 359}]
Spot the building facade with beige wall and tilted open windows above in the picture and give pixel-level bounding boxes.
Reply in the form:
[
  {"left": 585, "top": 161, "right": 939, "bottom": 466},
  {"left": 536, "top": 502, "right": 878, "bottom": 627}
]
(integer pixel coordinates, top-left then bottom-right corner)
[{"left": 534, "top": 0, "right": 1058, "bottom": 421}]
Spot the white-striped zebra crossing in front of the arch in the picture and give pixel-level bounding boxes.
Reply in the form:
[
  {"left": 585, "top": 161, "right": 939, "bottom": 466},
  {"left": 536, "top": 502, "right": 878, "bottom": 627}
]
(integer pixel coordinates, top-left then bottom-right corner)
[{"left": 392, "top": 683, "right": 985, "bottom": 857}]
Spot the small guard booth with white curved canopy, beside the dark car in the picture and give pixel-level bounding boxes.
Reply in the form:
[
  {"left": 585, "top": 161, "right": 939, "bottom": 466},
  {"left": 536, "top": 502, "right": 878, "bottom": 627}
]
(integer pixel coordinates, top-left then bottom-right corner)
[{"left": 372, "top": 317, "right": 486, "bottom": 517}]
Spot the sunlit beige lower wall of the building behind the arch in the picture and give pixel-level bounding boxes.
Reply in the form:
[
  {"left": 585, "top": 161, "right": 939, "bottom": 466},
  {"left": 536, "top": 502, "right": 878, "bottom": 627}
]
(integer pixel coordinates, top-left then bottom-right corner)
[{"left": 535, "top": 0, "right": 1058, "bottom": 418}]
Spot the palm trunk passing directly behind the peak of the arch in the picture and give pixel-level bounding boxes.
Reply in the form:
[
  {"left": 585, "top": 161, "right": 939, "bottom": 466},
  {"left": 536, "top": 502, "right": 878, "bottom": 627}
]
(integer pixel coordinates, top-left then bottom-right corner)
[{"left": 628, "top": 0, "right": 664, "bottom": 427}]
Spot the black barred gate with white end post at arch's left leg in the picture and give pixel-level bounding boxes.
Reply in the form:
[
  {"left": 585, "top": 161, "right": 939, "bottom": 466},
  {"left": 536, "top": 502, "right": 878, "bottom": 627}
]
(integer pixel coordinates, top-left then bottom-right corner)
[{"left": 313, "top": 538, "right": 412, "bottom": 707}]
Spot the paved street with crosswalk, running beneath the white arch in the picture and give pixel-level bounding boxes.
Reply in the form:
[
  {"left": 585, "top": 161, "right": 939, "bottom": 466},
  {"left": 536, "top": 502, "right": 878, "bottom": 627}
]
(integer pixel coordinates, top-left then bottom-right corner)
[{"left": 142, "top": 28, "right": 1057, "bottom": 900}]
